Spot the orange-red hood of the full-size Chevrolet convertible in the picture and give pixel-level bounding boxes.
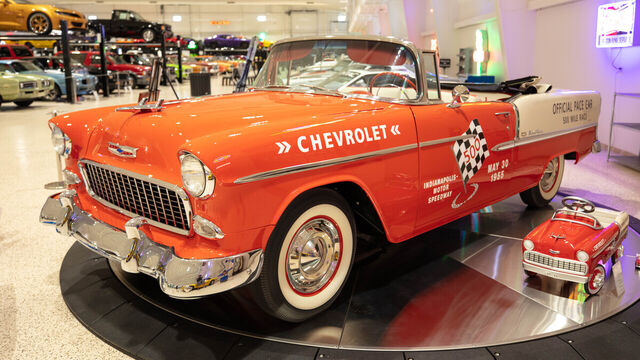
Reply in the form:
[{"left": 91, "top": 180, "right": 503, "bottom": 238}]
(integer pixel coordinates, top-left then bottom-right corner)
[{"left": 79, "top": 91, "right": 391, "bottom": 183}]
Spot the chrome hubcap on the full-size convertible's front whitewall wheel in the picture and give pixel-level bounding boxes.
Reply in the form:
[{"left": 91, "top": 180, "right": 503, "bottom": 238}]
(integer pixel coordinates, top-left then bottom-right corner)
[{"left": 287, "top": 219, "right": 341, "bottom": 294}]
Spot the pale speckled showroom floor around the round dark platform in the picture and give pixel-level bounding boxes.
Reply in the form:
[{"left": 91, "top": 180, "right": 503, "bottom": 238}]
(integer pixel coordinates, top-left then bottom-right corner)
[{"left": 0, "top": 80, "right": 640, "bottom": 359}]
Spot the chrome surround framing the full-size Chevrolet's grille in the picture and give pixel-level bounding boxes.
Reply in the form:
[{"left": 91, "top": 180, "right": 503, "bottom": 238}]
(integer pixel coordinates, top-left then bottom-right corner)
[{"left": 78, "top": 159, "right": 193, "bottom": 235}]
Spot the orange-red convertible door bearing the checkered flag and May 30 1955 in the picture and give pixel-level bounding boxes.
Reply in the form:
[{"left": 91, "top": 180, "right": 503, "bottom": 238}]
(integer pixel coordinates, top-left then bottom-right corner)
[{"left": 411, "top": 54, "right": 516, "bottom": 231}]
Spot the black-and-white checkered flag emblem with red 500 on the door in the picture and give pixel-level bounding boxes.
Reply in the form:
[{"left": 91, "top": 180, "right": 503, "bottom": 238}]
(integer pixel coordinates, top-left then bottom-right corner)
[{"left": 453, "top": 119, "right": 489, "bottom": 185}]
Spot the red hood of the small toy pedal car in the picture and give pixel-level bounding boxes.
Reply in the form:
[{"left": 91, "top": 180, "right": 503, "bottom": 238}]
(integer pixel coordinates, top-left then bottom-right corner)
[{"left": 527, "top": 220, "right": 602, "bottom": 260}]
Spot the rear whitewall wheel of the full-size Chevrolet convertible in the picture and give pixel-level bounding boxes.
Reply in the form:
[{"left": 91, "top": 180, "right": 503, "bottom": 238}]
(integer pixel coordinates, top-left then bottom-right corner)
[{"left": 520, "top": 155, "right": 564, "bottom": 208}]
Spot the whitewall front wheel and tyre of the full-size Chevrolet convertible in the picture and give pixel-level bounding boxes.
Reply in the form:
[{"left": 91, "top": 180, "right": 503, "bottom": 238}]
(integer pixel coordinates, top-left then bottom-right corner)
[{"left": 249, "top": 189, "right": 356, "bottom": 322}]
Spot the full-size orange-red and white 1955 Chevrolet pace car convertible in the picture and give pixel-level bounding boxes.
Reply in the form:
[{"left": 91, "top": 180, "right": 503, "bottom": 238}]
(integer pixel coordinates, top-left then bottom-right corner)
[{"left": 40, "top": 37, "right": 600, "bottom": 322}]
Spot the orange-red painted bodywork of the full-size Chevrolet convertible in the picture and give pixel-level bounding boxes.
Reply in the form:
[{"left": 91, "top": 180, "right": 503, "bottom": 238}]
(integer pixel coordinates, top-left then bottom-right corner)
[{"left": 52, "top": 89, "right": 595, "bottom": 258}]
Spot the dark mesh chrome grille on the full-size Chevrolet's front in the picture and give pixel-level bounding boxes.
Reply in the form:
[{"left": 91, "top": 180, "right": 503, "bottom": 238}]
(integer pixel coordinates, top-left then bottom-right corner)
[{"left": 81, "top": 160, "right": 191, "bottom": 234}]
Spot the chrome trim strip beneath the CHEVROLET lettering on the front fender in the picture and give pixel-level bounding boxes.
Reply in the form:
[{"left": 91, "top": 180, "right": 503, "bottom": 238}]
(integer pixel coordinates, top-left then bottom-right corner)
[{"left": 234, "top": 144, "right": 418, "bottom": 184}]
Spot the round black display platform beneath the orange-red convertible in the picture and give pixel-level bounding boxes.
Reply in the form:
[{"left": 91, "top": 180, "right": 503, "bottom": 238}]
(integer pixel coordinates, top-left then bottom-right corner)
[{"left": 60, "top": 199, "right": 640, "bottom": 360}]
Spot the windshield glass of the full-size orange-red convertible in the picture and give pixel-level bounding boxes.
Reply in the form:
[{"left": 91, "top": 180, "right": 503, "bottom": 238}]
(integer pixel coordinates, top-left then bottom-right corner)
[{"left": 255, "top": 40, "right": 419, "bottom": 100}]
